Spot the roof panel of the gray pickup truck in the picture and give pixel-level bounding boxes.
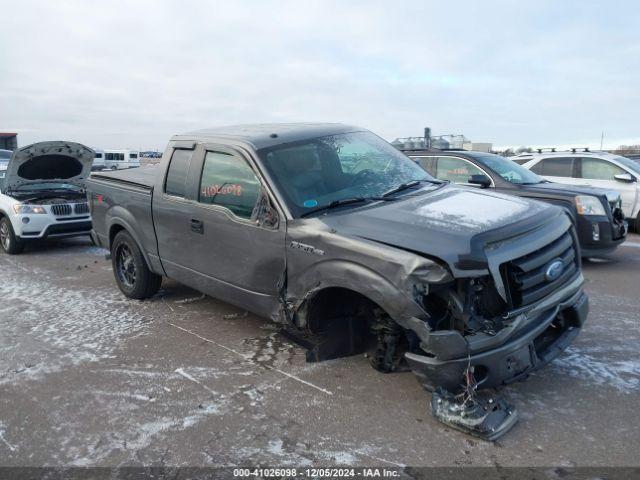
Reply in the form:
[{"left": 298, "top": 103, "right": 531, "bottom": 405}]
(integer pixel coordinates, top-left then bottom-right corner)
[{"left": 171, "top": 123, "right": 365, "bottom": 150}]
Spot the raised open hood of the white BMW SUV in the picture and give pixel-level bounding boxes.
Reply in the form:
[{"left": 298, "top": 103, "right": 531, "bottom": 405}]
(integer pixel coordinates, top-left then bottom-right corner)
[{"left": 4, "top": 141, "right": 94, "bottom": 190}]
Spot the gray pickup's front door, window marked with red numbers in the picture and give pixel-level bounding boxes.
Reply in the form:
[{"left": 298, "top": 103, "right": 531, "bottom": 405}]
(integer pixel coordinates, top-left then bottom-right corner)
[{"left": 175, "top": 144, "right": 285, "bottom": 315}]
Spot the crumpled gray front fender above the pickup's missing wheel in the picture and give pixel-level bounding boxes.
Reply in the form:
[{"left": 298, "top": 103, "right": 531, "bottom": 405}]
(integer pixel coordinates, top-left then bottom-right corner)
[{"left": 285, "top": 225, "right": 453, "bottom": 340}]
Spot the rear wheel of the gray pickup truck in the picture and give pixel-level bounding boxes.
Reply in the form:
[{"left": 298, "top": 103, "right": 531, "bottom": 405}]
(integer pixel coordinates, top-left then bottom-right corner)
[{"left": 111, "top": 230, "right": 162, "bottom": 300}]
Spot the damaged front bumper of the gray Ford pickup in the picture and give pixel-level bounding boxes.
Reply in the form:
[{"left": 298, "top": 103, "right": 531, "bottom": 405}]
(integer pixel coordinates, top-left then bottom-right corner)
[{"left": 405, "top": 291, "right": 589, "bottom": 392}]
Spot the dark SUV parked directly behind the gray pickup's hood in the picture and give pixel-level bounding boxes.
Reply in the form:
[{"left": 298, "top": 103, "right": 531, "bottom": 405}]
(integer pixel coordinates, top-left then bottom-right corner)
[{"left": 404, "top": 150, "right": 627, "bottom": 257}]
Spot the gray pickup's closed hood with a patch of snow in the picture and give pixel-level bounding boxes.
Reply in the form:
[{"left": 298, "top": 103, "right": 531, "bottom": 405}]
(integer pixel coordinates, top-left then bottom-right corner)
[{"left": 320, "top": 185, "right": 560, "bottom": 270}]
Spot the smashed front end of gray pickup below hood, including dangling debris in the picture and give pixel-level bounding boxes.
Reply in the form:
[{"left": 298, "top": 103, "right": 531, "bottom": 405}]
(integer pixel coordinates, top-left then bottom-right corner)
[{"left": 284, "top": 201, "right": 588, "bottom": 440}]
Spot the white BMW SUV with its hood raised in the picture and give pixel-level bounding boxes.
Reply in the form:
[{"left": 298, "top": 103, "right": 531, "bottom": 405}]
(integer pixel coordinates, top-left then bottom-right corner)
[{"left": 0, "top": 141, "right": 93, "bottom": 254}]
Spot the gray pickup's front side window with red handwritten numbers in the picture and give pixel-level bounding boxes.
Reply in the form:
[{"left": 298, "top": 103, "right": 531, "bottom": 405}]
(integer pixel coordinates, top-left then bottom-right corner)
[{"left": 198, "top": 152, "right": 260, "bottom": 219}]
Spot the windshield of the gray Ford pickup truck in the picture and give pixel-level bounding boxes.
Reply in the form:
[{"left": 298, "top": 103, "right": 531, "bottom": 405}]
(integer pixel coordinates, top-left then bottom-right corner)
[{"left": 258, "top": 132, "right": 440, "bottom": 217}]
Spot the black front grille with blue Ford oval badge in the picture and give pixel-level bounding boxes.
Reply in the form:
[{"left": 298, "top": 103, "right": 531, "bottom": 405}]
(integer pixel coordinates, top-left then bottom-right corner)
[{"left": 501, "top": 231, "right": 579, "bottom": 308}]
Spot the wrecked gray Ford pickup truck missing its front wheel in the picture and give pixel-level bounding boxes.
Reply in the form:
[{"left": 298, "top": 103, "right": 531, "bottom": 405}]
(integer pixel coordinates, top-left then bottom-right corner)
[{"left": 87, "top": 124, "right": 588, "bottom": 438}]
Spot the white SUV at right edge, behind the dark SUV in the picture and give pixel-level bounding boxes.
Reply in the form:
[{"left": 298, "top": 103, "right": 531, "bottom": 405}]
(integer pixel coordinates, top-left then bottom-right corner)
[{"left": 514, "top": 149, "right": 640, "bottom": 232}]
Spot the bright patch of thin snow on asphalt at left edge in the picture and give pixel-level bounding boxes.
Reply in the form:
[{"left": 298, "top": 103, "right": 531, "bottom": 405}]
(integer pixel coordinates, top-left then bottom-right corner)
[{"left": 0, "top": 264, "right": 149, "bottom": 384}]
